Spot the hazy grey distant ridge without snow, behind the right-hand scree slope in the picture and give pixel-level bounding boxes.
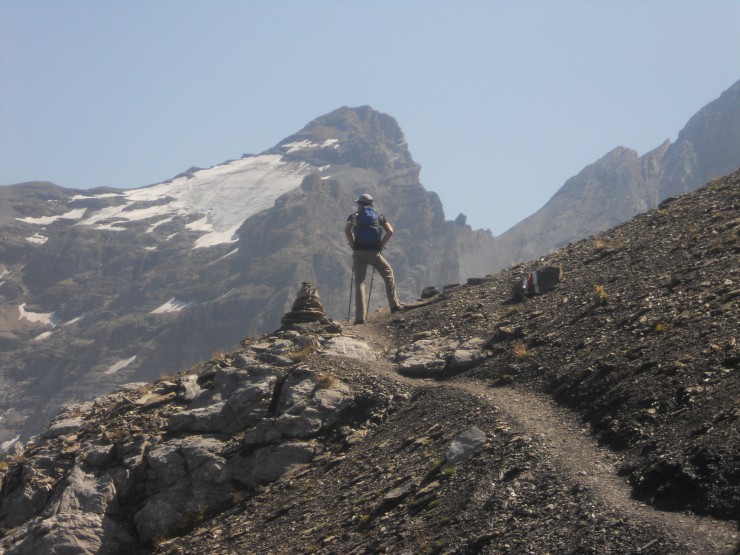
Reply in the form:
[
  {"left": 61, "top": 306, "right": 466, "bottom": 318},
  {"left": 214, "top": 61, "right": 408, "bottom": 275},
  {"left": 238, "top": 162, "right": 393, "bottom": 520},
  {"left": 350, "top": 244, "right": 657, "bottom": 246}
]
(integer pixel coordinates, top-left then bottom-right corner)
[{"left": 493, "top": 81, "right": 740, "bottom": 269}]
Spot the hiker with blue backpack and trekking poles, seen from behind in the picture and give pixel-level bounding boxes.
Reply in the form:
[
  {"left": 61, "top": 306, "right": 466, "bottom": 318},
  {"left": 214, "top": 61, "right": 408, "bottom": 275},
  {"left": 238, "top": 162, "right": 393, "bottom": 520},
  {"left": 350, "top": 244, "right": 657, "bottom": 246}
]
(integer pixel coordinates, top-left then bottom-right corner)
[{"left": 344, "top": 194, "right": 403, "bottom": 324}]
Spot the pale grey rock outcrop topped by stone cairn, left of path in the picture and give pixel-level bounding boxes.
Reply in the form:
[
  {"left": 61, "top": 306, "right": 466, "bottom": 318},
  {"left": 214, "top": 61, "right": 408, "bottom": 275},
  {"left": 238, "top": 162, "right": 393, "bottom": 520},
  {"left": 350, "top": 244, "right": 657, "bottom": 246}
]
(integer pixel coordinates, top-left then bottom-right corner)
[{"left": 0, "top": 310, "right": 381, "bottom": 553}]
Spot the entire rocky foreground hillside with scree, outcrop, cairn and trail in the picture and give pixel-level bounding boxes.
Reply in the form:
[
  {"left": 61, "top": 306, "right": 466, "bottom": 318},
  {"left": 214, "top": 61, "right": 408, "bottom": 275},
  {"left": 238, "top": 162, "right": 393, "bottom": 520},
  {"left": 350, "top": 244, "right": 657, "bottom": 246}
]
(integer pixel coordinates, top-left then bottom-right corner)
[{"left": 0, "top": 172, "right": 740, "bottom": 555}]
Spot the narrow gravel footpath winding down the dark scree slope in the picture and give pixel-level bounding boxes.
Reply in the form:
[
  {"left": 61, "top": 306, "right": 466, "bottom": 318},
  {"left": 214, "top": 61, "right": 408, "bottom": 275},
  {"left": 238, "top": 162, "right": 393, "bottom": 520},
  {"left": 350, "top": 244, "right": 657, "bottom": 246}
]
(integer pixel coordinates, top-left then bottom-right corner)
[{"left": 347, "top": 322, "right": 740, "bottom": 555}]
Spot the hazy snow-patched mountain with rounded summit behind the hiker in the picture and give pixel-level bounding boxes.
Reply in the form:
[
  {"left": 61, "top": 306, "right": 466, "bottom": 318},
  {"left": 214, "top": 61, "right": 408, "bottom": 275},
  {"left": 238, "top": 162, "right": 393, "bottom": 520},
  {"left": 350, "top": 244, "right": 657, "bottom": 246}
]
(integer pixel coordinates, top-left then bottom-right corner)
[{"left": 0, "top": 107, "right": 498, "bottom": 448}]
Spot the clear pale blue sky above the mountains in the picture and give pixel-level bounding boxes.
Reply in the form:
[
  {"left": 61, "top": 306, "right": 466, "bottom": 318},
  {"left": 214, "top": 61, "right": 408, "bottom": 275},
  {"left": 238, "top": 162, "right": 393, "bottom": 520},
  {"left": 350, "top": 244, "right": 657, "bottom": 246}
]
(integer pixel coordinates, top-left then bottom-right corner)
[{"left": 0, "top": 0, "right": 740, "bottom": 234}]
